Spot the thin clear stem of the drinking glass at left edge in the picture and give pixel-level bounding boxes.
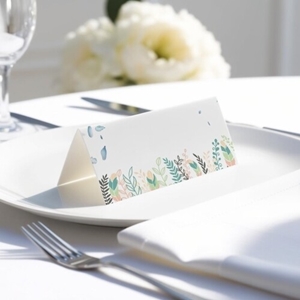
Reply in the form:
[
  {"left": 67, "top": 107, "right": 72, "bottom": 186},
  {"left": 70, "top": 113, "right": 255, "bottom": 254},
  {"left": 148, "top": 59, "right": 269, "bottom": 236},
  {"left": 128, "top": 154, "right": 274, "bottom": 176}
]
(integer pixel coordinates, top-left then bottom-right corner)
[{"left": 0, "top": 65, "right": 12, "bottom": 127}]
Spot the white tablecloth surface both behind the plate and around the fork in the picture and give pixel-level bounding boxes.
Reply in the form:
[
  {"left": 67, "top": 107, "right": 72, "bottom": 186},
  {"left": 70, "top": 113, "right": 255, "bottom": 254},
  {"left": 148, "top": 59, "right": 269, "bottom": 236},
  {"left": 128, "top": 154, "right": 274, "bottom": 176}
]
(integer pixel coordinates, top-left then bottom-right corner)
[{"left": 0, "top": 77, "right": 300, "bottom": 299}]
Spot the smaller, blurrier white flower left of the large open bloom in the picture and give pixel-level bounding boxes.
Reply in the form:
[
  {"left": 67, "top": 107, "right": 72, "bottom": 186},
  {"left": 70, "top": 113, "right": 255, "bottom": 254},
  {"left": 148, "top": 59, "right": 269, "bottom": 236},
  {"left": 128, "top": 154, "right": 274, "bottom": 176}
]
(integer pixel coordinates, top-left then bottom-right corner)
[{"left": 60, "top": 17, "right": 124, "bottom": 92}]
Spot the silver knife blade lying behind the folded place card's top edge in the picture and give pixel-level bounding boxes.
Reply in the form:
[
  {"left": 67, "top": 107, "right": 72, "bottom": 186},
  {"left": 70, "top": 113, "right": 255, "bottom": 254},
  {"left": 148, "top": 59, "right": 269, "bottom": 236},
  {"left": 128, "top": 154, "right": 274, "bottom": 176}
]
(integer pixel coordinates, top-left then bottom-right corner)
[{"left": 81, "top": 97, "right": 150, "bottom": 115}]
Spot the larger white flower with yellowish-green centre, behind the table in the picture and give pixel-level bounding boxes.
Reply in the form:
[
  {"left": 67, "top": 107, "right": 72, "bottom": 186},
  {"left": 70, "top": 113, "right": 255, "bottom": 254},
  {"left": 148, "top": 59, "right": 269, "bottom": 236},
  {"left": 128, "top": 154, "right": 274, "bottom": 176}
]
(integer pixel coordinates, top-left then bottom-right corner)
[{"left": 116, "top": 1, "right": 230, "bottom": 84}]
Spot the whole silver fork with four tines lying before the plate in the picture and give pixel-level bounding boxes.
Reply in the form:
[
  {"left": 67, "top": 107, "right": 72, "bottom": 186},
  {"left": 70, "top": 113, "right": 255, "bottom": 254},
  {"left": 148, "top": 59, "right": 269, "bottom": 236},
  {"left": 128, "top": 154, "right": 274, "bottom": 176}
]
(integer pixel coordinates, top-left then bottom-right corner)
[{"left": 21, "top": 222, "right": 205, "bottom": 300}]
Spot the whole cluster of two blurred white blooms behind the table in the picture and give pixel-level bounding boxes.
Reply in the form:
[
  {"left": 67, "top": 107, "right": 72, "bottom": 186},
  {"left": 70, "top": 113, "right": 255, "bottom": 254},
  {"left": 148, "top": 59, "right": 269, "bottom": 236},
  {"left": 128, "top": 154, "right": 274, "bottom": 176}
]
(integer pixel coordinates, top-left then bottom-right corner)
[{"left": 60, "top": 1, "right": 230, "bottom": 92}]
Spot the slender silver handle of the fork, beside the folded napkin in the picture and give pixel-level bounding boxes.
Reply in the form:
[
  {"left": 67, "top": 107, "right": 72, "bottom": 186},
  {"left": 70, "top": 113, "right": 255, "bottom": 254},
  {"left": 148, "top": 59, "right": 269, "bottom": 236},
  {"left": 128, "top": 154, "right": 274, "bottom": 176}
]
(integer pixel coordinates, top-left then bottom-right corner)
[{"left": 101, "top": 261, "right": 207, "bottom": 300}]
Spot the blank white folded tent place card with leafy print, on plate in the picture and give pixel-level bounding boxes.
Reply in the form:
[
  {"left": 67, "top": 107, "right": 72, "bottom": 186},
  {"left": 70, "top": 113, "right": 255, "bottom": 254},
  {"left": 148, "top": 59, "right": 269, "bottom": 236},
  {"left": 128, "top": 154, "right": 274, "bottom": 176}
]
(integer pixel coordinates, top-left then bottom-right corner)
[{"left": 58, "top": 98, "right": 236, "bottom": 205}]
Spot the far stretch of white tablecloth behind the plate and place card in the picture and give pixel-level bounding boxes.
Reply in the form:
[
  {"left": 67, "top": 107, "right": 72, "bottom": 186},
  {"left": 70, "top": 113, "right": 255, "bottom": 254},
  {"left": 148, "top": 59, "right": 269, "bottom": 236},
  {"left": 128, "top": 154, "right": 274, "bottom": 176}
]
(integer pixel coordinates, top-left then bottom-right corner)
[{"left": 11, "top": 77, "right": 300, "bottom": 132}]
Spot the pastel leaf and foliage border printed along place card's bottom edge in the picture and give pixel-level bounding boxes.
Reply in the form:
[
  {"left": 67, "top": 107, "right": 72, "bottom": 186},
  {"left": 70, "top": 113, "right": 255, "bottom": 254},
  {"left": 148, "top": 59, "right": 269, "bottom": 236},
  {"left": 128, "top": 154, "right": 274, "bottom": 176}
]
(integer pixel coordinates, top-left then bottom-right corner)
[{"left": 99, "top": 135, "right": 236, "bottom": 204}]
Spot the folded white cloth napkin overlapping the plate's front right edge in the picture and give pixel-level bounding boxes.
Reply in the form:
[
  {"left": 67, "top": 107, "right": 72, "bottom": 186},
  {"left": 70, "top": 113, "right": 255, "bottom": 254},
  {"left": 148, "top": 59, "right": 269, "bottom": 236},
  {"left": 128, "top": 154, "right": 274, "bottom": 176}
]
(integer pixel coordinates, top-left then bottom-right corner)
[{"left": 118, "top": 170, "right": 300, "bottom": 298}]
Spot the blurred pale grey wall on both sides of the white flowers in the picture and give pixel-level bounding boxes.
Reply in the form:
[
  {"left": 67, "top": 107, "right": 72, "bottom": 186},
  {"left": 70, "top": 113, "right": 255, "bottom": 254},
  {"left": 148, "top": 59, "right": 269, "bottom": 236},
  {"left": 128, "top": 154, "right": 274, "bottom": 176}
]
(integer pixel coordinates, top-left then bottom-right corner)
[{"left": 10, "top": 0, "right": 300, "bottom": 102}]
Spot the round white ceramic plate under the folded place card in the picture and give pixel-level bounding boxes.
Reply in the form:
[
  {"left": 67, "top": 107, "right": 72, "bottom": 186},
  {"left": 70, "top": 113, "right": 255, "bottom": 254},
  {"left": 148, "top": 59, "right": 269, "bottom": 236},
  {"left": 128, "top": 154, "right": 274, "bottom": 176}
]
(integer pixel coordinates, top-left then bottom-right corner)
[{"left": 0, "top": 124, "right": 300, "bottom": 227}]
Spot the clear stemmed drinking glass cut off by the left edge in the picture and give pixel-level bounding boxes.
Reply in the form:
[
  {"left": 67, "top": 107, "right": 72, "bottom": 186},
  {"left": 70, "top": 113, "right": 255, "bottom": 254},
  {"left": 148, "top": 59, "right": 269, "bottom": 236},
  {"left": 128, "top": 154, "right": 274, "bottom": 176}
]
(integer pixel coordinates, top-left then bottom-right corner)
[{"left": 0, "top": 0, "right": 36, "bottom": 140}]
